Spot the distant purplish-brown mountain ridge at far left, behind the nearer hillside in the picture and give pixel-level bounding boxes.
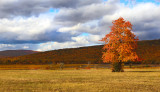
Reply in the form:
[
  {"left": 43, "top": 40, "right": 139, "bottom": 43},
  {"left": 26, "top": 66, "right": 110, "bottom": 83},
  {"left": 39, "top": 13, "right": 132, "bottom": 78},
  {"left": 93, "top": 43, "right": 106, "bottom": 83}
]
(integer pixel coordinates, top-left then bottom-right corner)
[{"left": 0, "top": 50, "right": 38, "bottom": 58}]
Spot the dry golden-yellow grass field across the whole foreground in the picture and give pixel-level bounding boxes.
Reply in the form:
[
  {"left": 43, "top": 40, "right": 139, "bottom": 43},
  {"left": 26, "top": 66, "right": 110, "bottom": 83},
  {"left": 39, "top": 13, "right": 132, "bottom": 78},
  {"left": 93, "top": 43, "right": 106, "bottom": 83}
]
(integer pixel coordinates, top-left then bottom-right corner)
[{"left": 0, "top": 69, "right": 160, "bottom": 92}]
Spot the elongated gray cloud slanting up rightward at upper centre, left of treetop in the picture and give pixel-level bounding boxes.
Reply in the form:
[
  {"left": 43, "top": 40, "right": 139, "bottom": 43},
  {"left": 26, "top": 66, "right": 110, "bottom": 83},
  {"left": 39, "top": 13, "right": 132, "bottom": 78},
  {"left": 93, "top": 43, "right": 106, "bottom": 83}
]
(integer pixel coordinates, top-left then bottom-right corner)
[{"left": 54, "top": 2, "right": 118, "bottom": 25}]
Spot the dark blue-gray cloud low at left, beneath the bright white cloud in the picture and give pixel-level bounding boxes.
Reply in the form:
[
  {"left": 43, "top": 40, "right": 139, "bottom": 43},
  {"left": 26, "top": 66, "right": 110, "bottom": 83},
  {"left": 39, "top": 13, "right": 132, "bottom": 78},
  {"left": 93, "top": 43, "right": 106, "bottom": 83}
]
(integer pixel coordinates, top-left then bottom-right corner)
[{"left": 0, "top": 30, "right": 77, "bottom": 44}]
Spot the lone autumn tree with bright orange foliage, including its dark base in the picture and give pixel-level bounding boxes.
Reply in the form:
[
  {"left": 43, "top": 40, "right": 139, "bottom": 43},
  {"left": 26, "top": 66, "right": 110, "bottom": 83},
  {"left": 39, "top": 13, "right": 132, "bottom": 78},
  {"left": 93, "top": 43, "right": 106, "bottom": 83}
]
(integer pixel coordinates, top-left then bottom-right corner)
[{"left": 101, "top": 17, "right": 138, "bottom": 72}]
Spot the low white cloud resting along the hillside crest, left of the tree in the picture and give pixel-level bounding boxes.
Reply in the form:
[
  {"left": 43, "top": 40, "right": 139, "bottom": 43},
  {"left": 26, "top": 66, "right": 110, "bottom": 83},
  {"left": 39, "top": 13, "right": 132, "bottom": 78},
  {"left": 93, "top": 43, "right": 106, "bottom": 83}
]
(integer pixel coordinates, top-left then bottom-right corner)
[{"left": 37, "top": 35, "right": 102, "bottom": 51}]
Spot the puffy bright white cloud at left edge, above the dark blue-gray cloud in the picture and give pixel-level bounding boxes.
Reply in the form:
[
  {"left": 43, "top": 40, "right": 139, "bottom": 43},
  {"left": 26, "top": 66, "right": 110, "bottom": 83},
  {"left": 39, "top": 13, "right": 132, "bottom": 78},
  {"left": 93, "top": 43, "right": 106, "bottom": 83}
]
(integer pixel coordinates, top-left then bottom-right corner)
[{"left": 0, "top": 17, "right": 52, "bottom": 40}]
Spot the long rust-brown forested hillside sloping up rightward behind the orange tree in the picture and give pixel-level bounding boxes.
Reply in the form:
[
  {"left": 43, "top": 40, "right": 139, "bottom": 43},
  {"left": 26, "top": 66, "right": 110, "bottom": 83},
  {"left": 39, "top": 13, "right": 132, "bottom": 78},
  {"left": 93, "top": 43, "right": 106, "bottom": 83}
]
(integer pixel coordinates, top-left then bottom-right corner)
[{"left": 0, "top": 40, "right": 160, "bottom": 64}]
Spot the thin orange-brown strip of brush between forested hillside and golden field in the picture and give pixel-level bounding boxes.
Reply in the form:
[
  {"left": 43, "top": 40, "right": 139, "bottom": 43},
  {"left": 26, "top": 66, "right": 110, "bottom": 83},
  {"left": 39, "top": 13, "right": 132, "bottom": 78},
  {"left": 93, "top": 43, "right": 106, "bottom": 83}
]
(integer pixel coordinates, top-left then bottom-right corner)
[{"left": 0, "top": 64, "right": 160, "bottom": 70}]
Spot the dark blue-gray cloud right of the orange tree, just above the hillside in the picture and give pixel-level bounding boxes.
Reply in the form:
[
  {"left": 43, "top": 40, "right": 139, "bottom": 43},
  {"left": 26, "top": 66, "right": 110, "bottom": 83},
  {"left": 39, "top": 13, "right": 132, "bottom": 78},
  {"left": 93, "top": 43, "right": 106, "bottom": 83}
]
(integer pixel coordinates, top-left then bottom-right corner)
[{"left": 133, "top": 19, "right": 160, "bottom": 40}]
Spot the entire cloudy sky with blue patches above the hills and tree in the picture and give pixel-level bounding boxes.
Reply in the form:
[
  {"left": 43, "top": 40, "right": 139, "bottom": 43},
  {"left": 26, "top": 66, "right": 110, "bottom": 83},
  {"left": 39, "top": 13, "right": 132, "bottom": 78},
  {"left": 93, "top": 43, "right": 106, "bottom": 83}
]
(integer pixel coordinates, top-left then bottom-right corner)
[{"left": 0, "top": 0, "right": 160, "bottom": 51}]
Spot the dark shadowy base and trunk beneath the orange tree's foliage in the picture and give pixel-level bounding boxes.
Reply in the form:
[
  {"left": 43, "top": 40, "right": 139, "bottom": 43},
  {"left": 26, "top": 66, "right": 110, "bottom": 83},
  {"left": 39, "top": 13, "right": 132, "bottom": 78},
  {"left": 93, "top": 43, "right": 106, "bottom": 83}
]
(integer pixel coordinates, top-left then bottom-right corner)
[{"left": 112, "top": 61, "right": 124, "bottom": 72}]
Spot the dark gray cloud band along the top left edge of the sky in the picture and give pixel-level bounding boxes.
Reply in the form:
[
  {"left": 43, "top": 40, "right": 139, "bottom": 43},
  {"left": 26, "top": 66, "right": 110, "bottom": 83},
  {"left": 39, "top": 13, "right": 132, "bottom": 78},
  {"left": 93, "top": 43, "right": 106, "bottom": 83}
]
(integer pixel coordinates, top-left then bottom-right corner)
[{"left": 0, "top": 0, "right": 101, "bottom": 18}]
